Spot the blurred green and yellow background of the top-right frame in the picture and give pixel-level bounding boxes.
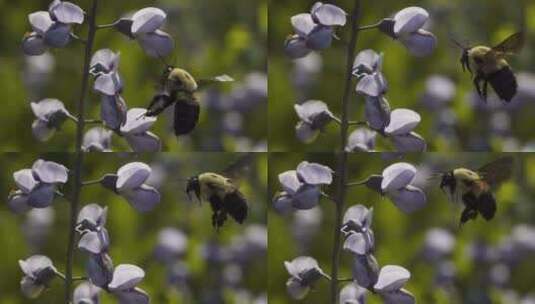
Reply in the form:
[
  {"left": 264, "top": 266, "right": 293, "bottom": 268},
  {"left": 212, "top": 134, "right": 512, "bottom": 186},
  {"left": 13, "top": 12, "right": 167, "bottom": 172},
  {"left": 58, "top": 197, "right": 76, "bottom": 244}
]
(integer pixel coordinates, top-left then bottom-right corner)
[{"left": 268, "top": 0, "right": 535, "bottom": 152}]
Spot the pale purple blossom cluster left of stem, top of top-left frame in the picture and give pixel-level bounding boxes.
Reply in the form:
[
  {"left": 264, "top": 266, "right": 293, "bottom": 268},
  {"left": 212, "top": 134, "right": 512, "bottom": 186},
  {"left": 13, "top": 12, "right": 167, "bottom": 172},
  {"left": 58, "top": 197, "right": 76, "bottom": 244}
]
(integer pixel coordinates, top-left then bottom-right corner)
[{"left": 22, "top": 0, "right": 84, "bottom": 56}]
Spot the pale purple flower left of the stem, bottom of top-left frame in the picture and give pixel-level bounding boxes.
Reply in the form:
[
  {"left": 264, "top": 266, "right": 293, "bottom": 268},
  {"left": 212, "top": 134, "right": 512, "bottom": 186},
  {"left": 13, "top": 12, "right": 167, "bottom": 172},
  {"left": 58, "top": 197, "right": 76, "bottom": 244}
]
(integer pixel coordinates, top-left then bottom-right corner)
[{"left": 31, "top": 98, "right": 71, "bottom": 141}]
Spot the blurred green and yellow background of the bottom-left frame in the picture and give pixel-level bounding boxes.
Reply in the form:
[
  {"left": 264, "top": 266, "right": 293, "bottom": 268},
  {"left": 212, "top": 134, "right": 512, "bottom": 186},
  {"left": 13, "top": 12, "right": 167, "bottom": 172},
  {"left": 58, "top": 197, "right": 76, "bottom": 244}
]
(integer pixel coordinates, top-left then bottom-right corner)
[{"left": 0, "top": 153, "right": 267, "bottom": 304}]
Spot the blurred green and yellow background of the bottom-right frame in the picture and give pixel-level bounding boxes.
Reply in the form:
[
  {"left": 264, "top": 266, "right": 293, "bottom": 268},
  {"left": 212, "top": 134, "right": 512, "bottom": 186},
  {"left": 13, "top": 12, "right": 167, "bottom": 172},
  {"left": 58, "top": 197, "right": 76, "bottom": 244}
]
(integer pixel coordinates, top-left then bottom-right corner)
[{"left": 268, "top": 153, "right": 535, "bottom": 304}]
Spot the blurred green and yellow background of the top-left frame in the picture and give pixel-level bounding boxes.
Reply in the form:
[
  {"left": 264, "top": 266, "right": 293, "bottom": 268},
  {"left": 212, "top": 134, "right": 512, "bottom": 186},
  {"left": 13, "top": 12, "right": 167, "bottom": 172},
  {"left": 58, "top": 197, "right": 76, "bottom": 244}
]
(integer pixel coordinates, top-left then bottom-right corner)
[{"left": 0, "top": 0, "right": 267, "bottom": 152}]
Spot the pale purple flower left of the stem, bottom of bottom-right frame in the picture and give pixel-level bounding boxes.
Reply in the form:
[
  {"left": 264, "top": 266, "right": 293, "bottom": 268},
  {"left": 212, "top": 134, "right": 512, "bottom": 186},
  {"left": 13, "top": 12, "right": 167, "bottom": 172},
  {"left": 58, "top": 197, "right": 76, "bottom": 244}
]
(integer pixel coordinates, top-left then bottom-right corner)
[{"left": 284, "top": 256, "right": 330, "bottom": 300}]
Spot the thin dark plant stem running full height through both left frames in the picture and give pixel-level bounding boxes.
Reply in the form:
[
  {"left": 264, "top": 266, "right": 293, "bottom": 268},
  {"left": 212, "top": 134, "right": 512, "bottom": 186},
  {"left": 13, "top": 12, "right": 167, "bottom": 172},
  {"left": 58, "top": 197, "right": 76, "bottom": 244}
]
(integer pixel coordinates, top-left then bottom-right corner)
[{"left": 64, "top": 0, "right": 98, "bottom": 304}]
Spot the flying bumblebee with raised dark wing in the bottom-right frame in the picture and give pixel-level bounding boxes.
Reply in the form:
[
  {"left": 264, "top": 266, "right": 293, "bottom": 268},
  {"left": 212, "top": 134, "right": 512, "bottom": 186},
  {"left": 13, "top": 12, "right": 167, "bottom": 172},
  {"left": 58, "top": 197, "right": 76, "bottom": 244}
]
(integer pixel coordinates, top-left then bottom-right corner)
[{"left": 440, "top": 157, "right": 513, "bottom": 225}]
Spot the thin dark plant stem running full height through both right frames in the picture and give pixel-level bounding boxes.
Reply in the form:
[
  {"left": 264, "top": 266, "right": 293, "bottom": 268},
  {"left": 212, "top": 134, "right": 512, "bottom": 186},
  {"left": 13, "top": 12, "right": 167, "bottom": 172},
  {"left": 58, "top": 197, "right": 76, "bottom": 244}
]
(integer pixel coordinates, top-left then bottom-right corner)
[{"left": 330, "top": 0, "right": 361, "bottom": 304}]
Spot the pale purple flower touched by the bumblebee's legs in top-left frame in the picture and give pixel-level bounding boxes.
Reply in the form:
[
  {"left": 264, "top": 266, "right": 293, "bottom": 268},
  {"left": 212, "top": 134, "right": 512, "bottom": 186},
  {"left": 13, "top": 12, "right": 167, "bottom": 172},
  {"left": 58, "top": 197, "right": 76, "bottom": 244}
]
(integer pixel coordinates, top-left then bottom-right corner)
[{"left": 120, "top": 108, "right": 161, "bottom": 152}]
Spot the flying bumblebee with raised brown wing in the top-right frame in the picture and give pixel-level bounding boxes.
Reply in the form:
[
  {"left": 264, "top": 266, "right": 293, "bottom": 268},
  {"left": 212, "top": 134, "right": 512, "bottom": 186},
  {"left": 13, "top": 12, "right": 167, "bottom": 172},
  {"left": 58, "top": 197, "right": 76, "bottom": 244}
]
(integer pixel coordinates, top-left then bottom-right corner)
[{"left": 454, "top": 32, "right": 524, "bottom": 102}]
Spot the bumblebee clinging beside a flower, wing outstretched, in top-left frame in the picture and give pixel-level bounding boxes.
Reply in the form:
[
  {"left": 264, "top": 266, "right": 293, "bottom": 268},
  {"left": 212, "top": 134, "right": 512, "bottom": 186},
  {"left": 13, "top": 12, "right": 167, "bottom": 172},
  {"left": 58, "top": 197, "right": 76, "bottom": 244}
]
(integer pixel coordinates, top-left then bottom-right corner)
[{"left": 145, "top": 66, "right": 234, "bottom": 136}]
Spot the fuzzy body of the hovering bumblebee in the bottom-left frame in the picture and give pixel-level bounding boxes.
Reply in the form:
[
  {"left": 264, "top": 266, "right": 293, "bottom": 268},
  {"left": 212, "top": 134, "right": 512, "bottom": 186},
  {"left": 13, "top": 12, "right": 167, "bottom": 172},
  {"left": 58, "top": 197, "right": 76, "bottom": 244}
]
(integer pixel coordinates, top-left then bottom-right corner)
[{"left": 186, "top": 172, "right": 248, "bottom": 230}]
